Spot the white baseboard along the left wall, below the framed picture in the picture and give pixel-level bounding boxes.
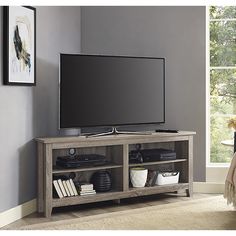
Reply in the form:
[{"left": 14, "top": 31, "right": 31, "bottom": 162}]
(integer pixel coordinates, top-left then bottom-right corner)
[{"left": 0, "top": 199, "right": 36, "bottom": 228}]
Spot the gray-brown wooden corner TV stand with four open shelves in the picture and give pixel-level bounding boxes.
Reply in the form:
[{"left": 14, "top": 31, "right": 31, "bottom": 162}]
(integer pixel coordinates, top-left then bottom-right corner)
[{"left": 36, "top": 131, "right": 195, "bottom": 217}]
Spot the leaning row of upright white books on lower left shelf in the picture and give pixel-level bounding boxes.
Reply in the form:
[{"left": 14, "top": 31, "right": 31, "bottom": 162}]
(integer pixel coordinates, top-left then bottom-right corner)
[{"left": 53, "top": 179, "right": 78, "bottom": 198}]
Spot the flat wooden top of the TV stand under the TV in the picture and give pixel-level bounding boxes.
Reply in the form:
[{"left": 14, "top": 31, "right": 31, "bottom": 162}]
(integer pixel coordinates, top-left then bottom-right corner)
[{"left": 35, "top": 131, "right": 196, "bottom": 145}]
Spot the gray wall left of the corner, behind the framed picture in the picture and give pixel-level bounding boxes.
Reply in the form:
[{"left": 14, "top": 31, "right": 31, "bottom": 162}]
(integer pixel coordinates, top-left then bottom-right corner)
[{"left": 0, "top": 7, "right": 81, "bottom": 212}]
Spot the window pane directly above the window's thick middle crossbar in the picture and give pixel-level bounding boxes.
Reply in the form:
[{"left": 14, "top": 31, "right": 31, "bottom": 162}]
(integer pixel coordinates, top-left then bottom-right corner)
[{"left": 210, "top": 21, "right": 236, "bottom": 66}]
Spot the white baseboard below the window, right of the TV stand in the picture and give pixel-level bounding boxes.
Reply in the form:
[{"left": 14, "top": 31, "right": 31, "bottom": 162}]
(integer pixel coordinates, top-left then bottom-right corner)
[{"left": 193, "top": 182, "right": 225, "bottom": 194}]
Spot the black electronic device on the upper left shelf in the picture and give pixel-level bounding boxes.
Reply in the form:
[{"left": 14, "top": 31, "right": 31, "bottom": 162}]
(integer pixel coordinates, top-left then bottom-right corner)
[{"left": 56, "top": 154, "right": 107, "bottom": 168}]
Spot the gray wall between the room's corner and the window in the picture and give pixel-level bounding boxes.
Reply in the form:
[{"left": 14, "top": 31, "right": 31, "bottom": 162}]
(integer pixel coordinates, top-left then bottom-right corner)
[{"left": 81, "top": 6, "right": 206, "bottom": 181}]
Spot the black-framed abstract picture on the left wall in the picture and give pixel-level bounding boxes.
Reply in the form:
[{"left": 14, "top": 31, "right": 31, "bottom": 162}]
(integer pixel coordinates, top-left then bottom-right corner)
[{"left": 3, "top": 6, "right": 36, "bottom": 86}]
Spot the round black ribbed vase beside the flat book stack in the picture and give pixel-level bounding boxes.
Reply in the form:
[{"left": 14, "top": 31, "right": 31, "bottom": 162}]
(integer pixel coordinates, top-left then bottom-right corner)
[{"left": 90, "top": 170, "right": 111, "bottom": 192}]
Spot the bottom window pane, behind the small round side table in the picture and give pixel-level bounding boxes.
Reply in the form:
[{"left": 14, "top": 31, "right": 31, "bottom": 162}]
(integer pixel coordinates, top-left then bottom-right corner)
[{"left": 210, "top": 115, "right": 233, "bottom": 163}]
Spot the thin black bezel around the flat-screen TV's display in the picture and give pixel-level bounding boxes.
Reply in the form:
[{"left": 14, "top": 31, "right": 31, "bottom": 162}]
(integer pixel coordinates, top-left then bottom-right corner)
[{"left": 58, "top": 53, "right": 166, "bottom": 130}]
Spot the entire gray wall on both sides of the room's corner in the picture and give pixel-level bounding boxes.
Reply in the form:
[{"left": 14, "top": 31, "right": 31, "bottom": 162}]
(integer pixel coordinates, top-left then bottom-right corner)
[{"left": 0, "top": 6, "right": 205, "bottom": 212}]
